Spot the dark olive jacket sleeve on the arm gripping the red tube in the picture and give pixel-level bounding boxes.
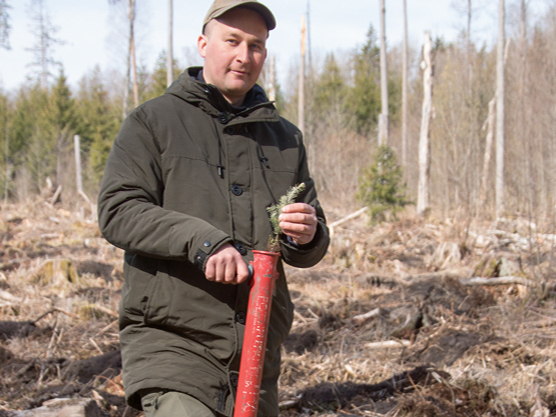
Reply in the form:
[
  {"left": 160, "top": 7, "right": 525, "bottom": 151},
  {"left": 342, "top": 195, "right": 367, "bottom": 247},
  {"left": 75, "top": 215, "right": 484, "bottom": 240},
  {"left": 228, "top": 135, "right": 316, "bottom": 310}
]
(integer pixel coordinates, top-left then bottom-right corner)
[{"left": 98, "top": 108, "right": 231, "bottom": 269}]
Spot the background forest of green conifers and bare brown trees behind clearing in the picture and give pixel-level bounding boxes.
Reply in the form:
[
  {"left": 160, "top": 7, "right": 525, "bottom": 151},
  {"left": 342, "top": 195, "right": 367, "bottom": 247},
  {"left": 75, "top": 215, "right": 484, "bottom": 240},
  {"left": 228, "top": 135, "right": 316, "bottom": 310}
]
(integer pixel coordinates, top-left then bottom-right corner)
[{"left": 0, "top": 0, "right": 556, "bottom": 224}]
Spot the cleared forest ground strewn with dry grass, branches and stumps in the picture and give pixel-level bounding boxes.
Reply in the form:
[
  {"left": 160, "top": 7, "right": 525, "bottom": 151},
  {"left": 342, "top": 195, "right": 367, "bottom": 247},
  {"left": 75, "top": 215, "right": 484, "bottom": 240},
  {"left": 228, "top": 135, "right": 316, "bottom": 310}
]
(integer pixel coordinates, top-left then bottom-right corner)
[{"left": 0, "top": 199, "right": 556, "bottom": 417}]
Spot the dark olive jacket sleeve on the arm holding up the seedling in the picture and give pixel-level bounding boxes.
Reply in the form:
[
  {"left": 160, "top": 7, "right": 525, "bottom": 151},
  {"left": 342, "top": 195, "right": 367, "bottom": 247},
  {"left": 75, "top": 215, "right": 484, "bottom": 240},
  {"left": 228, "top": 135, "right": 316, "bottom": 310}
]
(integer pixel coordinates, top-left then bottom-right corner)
[{"left": 280, "top": 133, "right": 330, "bottom": 268}]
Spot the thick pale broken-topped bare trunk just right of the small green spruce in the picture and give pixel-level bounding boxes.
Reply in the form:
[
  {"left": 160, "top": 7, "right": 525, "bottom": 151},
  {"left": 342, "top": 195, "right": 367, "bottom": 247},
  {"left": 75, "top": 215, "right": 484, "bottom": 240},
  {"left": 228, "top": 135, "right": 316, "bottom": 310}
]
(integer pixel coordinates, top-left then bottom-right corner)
[{"left": 417, "top": 31, "right": 433, "bottom": 216}]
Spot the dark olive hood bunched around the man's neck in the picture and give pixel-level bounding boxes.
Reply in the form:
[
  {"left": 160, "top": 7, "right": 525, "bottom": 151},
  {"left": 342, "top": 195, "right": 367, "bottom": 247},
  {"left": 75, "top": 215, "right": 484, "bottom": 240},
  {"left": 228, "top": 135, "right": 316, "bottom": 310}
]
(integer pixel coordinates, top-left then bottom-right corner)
[{"left": 166, "top": 67, "right": 279, "bottom": 122}]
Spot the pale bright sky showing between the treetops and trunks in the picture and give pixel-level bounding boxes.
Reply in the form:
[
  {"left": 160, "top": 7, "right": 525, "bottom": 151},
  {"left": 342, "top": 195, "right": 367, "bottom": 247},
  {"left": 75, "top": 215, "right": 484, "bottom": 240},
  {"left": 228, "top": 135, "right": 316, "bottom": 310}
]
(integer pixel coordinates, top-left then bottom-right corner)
[{"left": 0, "top": 0, "right": 541, "bottom": 91}]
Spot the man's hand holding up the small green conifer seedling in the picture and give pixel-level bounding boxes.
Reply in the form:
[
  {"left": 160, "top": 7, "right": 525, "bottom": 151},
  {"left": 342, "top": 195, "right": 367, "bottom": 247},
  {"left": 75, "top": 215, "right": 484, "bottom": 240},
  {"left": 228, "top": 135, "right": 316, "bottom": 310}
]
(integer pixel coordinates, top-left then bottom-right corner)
[{"left": 279, "top": 203, "right": 318, "bottom": 245}]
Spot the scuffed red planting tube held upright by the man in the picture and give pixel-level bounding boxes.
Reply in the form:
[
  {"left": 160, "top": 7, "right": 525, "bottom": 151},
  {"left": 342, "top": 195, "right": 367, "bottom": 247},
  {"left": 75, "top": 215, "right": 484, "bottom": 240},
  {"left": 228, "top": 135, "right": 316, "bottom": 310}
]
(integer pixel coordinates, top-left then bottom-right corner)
[{"left": 234, "top": 250, "right": 280, "bottom": 417}]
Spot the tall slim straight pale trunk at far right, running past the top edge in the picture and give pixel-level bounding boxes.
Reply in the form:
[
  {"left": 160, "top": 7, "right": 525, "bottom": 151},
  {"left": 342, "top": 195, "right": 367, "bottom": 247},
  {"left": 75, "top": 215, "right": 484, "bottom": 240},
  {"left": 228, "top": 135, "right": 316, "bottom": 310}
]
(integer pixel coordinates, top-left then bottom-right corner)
[{"left": 496, "top": 0, "right": 505, "bottom": 216}]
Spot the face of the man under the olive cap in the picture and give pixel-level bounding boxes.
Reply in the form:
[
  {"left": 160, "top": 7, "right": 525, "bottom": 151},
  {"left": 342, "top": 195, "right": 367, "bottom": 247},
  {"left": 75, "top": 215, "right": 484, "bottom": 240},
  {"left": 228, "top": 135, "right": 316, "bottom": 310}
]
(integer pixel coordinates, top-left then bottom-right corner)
[{"left": 197, "top": 7, "right": 268, "bottom": 106}]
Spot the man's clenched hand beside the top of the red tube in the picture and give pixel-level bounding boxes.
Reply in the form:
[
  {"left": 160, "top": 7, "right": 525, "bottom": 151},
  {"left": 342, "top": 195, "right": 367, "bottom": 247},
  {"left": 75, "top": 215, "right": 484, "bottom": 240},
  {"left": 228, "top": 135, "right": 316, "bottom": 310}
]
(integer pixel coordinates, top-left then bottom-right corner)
[{"left": 205, "top": 243, "right": 249, "bottom": 284}]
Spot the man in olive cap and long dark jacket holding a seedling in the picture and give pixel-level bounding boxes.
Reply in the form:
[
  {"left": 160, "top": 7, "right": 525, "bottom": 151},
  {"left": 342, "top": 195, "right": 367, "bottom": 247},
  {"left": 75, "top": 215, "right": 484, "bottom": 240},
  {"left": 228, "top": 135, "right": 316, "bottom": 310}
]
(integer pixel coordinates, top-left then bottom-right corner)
[{"left": 99, "top": 0, "right": 328, "bottom": 417}]
